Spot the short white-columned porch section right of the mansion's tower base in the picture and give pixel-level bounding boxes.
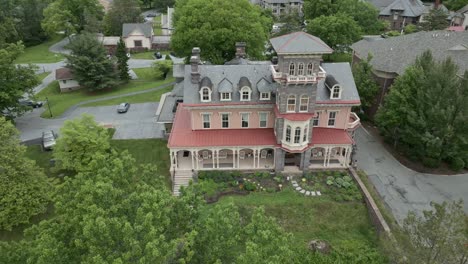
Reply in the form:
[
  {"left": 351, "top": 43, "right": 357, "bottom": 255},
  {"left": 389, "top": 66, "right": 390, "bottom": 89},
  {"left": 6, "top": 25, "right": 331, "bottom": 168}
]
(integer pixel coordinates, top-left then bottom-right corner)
[{"left": 309, "top": 145, "right": 352, "bottom": 169}]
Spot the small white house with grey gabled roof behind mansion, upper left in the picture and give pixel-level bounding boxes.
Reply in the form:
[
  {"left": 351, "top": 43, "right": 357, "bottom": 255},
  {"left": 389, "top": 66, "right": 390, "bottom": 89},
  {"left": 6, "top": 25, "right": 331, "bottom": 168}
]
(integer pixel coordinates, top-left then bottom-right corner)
[{"left": 122, "top": 23, "right": 154, "bottom": 51}]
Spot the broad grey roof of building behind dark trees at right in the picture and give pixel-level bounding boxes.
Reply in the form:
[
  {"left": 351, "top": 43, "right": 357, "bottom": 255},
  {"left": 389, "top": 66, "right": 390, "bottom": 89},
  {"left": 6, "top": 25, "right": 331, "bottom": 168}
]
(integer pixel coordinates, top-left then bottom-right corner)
[{"left": 351, "top": 30, "right": 468, "bottom": 75}]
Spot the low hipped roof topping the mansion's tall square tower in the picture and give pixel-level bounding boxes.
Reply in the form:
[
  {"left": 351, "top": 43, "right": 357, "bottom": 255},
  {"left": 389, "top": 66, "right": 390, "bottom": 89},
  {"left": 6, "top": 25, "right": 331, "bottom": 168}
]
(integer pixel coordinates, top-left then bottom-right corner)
[{"left": 270, "top": 31, "right": 333, "bottom": 54}]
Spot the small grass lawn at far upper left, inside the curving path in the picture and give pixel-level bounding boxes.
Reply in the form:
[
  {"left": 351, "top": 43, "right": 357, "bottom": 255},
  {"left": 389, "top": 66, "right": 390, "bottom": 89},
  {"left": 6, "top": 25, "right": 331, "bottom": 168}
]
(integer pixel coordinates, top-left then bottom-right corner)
[{"left": 15, "top": 35, "right": 64, "bottom": 63}]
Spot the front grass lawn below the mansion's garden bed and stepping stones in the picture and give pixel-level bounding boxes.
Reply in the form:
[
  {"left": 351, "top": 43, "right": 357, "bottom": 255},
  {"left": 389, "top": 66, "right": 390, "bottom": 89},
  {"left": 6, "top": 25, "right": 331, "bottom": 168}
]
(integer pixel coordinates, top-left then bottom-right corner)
[{"left": 219, "top": 188, "right": 384, "bottom": 251}]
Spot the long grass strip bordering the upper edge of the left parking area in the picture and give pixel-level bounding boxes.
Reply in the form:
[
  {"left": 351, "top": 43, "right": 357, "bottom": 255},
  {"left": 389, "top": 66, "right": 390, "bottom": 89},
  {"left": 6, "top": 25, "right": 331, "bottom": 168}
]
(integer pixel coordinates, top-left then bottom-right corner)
[{"left": 36, "top": 78, "right": 174, "bottom": 118}]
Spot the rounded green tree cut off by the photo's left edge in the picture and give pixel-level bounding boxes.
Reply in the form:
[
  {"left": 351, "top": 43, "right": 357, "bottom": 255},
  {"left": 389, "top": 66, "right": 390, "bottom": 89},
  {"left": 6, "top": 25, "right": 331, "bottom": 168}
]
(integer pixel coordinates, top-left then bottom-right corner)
[{"left": 0, "top": 117, "right": 52, "bottom": 230}]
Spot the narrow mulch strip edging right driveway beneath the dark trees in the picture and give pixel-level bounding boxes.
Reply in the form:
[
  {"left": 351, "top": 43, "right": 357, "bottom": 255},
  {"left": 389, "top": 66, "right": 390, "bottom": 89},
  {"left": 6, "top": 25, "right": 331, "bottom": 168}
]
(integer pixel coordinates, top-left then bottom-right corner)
[{"left": 362, "top": 122, "right": 468, "bottom": 175}]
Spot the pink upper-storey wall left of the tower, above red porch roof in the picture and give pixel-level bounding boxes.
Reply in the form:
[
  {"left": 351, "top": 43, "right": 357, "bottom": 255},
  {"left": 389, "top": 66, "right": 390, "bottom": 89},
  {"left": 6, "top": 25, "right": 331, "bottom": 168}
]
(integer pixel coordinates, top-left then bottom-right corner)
[{"left": 191, "top": 109, "right": 275, "bottom": 130}]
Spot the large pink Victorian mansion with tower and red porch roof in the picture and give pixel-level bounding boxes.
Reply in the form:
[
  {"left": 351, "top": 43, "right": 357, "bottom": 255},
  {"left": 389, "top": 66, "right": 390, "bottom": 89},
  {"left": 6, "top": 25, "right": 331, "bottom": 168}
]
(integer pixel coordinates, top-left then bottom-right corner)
[{"left": 156, "top": 32, "right": 360, "bottom": 194}]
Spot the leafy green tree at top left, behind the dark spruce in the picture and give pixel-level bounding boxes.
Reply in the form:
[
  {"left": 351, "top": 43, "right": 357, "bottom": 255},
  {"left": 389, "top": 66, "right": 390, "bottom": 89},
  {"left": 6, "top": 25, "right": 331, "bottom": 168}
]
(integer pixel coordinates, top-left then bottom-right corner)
[{"left": 42, "top": 0, "right": 104, "bottom": 36}]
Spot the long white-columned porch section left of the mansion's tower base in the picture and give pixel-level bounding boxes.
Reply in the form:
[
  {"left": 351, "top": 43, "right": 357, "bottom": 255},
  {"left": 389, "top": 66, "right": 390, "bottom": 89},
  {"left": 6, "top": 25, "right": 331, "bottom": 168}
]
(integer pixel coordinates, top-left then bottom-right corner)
[{"left": 170, "top": 146, "right": 275, "bottom": 171}]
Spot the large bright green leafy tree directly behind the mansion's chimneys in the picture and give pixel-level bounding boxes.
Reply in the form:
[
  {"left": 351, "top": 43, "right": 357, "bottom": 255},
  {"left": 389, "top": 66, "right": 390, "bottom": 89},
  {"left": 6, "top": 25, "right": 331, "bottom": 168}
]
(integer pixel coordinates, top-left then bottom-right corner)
[{"left": 171, "top": 0, "right": 272, "bottom": 64}]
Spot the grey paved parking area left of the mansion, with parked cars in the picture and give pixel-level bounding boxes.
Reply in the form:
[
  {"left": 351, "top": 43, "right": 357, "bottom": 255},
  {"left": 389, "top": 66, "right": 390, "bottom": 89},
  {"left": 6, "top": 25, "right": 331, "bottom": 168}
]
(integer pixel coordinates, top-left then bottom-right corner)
[{"left": 16, "top": 103, "right": 163, "bottom": 141}]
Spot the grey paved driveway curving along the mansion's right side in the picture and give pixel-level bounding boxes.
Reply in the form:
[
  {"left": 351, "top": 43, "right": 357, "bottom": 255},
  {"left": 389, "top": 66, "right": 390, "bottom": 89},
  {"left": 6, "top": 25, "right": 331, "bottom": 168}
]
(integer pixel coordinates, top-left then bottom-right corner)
[{"left": 356, "top": 128, "right": 468, "bottom": 223}]
